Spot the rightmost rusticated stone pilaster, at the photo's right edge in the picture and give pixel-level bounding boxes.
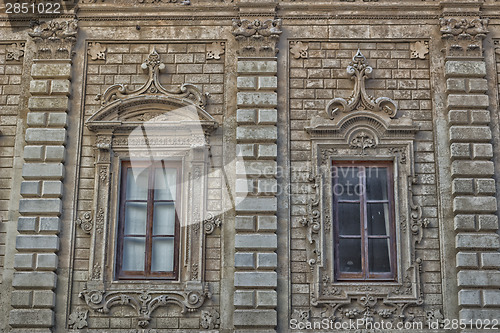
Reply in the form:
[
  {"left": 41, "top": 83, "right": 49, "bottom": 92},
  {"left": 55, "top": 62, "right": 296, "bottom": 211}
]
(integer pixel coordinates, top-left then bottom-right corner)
[{"left": 441, "top": 18, "right": 500, "bottom": 321}]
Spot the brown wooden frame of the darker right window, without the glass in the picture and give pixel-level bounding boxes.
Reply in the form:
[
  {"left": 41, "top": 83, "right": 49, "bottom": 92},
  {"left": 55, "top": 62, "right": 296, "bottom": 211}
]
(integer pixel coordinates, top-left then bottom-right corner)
[{"left": 332, "top": 161, "right": 397, "bottom": 282}]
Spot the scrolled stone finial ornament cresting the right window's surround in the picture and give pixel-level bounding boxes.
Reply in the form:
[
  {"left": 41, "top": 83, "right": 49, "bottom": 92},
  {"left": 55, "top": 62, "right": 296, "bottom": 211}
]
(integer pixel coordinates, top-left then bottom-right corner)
[{"left": 326, "top": 50, "right": 397, "bottom": 119}]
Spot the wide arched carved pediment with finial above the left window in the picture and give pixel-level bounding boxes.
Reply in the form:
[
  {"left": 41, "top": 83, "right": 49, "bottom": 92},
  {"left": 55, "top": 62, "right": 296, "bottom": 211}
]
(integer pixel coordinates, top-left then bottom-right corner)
[{"left": 87, "top": 50, "right": 218, "bottom": 131}]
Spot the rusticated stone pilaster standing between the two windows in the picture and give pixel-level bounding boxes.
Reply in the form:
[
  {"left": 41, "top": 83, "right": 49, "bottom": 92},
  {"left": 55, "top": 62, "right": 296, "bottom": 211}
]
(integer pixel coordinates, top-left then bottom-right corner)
[{"left": 233, "top": 20, "right": 280, "bottom": 332}]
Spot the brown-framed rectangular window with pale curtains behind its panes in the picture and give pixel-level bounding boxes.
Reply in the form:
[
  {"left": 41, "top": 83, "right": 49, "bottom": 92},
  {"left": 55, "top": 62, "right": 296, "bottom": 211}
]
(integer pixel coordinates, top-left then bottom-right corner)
[{"left": 117, "top": 161, "right": 181, "bottom": 279}]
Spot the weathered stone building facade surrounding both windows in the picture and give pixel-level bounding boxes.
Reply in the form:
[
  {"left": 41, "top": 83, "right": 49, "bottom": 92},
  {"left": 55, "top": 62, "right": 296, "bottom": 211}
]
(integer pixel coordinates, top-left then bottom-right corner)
[{"left": 0, "top": 0, "right": 500, "bottom": 333}]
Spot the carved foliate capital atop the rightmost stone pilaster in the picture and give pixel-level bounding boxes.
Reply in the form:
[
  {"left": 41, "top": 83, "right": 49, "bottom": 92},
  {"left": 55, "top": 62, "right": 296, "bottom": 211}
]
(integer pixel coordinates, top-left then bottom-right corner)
[{"left": 439, "top": 18, "right": 489, "bottom": 56}]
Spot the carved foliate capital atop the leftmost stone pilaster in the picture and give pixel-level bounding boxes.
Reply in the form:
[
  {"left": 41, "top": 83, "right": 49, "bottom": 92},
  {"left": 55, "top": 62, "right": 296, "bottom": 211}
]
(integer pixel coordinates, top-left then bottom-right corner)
[{"left": 28, "top": 19, "right": 78, "bottom": 59}]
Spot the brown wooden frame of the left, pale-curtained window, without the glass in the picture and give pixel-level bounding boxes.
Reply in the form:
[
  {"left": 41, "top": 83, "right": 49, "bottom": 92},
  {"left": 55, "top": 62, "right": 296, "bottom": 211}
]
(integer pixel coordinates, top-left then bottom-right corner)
[{"left": 116, "top": 160, "right": 182, "bottom": 280}]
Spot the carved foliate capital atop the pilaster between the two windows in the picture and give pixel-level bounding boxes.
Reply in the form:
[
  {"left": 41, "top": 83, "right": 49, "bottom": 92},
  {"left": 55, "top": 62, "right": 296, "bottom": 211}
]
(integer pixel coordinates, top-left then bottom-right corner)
[{"left": 232, "top": 19, "right": 282, "bottom": 57}]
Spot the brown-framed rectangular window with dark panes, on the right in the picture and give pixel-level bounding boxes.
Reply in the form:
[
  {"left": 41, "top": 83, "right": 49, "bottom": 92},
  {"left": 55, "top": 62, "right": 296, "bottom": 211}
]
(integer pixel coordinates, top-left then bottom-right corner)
[{"left": 332, "top": 161, "right": 396, "bottom": 281}]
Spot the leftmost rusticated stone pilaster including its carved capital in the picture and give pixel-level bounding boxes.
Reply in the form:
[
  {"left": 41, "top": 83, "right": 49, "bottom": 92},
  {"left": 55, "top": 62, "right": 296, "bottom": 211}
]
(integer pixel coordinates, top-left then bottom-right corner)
[{"left": 9, "top": 20, "right": 76, "bottom": 331}]
